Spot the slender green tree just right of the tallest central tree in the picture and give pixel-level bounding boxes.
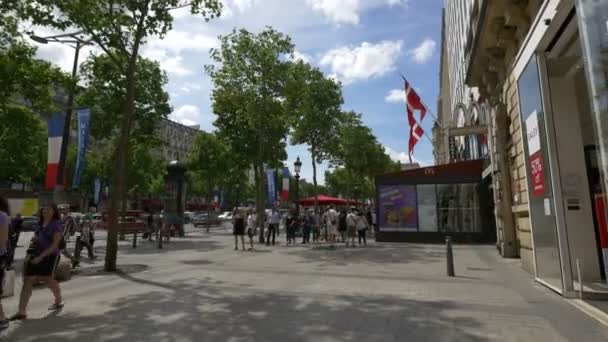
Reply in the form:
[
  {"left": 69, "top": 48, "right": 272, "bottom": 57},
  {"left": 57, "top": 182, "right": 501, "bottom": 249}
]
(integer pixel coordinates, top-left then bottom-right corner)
[{"left": 286, "top": 61, "right": 344, "bottom": 211}]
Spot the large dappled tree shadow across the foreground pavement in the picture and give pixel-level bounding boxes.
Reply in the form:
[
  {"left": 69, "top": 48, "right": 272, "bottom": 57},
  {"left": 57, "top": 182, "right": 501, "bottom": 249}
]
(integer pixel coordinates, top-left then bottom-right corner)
[{"left": 8, "top": 275, "right": 486, "bottom": 342}]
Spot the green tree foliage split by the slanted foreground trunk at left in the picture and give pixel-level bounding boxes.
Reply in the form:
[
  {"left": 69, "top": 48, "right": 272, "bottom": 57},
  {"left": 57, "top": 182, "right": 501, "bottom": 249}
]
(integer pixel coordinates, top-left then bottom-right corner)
[{"left": 79, "top": 54, "right": 172, "bottom": 202}]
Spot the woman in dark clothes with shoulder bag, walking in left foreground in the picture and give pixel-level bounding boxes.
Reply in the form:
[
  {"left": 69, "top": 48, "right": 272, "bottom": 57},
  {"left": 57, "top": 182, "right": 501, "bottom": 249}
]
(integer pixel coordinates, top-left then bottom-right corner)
[{"left": 10, "top": 205, "right": 64, "bottom": 321}]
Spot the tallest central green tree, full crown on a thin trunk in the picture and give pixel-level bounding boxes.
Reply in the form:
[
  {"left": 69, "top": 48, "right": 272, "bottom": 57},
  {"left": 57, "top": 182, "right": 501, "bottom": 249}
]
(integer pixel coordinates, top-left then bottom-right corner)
[{"left": 206, "top": 27, "right": 294, "bottom": 235}]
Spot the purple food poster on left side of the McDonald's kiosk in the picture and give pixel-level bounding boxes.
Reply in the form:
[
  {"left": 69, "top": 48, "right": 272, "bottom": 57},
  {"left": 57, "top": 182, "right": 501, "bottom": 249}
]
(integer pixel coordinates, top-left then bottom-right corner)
[{"left": 379, "top": 185, "right": 418, "bottom": 232}]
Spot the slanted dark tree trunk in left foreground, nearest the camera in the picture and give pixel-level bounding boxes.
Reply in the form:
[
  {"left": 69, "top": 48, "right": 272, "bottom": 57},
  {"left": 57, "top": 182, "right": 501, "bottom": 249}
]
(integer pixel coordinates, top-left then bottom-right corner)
[{"left": 104, "top": 14, "right": 147, "bottom": 272}]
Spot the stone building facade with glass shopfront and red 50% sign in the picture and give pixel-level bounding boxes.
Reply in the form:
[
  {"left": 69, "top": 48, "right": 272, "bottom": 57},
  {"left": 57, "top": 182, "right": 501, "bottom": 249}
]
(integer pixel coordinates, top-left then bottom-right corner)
[{"left": 454, "top": 0, "right": 608, "bottom": 296}]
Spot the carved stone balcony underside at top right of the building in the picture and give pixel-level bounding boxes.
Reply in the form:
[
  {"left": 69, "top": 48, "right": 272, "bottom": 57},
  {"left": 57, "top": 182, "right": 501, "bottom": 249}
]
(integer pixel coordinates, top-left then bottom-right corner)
[{"left": 465, "top": 0, "right": 542, "bottom": 99}]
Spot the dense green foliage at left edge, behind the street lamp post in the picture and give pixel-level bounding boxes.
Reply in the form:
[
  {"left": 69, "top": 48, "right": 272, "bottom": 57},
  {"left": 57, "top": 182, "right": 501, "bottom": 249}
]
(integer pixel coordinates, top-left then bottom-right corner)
[{"left": 0, "top": 40, "right": 68, "bottom": 183}]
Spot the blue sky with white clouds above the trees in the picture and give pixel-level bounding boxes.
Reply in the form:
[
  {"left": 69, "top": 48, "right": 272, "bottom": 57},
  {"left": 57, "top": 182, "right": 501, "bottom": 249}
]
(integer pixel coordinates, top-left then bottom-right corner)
[{"left": 32, "top": 0, "right": 442, "bottom": 182}]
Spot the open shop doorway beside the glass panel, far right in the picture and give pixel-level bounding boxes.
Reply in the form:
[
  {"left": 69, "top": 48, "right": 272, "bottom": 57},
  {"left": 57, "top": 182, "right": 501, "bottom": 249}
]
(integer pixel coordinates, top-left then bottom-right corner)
[{"left": 543, "top": 15, "right": 602, "bottom": 288}]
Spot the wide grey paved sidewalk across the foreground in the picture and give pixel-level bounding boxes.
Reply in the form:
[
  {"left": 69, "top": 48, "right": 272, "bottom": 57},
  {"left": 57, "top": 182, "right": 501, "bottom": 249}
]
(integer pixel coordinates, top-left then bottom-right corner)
[{"left": 0, "top": 230, "right": 608, "bottom": 342}]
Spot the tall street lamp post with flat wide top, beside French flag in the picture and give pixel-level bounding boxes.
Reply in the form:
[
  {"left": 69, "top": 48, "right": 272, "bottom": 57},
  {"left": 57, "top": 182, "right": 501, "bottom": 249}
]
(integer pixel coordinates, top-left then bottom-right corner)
[{"left": 30, "top": 31, "right": 91, "bottom": 203}]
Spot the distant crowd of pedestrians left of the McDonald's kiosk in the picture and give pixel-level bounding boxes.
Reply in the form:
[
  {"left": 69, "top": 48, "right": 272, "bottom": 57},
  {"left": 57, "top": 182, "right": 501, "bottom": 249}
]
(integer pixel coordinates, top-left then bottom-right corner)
[{"left": 232, "top": 206, "right": 376, "bottom": 250}]
